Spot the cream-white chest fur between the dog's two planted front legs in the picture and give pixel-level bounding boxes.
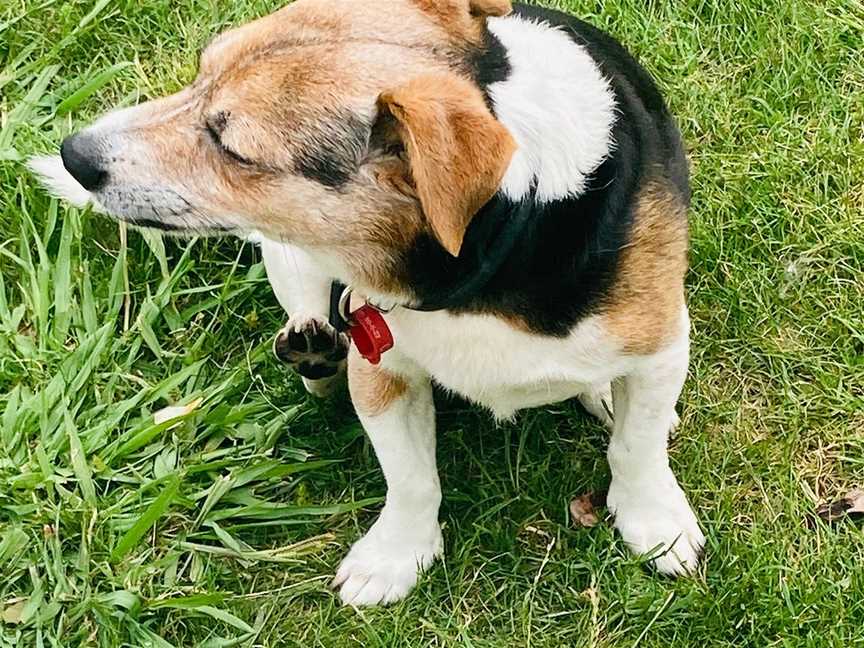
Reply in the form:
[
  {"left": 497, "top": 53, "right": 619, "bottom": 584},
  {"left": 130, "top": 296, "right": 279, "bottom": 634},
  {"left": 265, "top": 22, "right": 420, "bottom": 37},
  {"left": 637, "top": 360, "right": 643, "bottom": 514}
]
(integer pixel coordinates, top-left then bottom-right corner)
[{"left": 384, "top": 309, "right": 628, "bottom": 418}]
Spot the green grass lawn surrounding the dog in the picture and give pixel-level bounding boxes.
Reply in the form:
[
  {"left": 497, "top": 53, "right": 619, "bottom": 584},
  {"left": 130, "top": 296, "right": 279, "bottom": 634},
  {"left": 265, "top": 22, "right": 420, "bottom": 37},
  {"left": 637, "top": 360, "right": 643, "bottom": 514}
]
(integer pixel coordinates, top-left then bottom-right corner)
[{"left": 0, "top": 0, "right": 864, "bottom": 648}]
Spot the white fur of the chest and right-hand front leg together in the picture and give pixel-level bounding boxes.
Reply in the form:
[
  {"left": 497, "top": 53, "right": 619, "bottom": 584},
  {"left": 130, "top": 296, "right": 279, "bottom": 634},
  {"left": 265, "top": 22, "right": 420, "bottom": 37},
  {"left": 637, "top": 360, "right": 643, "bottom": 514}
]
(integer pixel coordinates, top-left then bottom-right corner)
[{"left": 384, "top": 309, "right": 705, "bottom": 574}]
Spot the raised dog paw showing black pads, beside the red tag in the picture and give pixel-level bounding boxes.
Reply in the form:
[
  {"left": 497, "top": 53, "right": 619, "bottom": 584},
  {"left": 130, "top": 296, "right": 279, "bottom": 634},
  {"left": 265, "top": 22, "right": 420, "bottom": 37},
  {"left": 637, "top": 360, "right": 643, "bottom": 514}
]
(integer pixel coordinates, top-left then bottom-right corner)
[{"left": 273, "top": 315, "right": 349, "bottom": 395}]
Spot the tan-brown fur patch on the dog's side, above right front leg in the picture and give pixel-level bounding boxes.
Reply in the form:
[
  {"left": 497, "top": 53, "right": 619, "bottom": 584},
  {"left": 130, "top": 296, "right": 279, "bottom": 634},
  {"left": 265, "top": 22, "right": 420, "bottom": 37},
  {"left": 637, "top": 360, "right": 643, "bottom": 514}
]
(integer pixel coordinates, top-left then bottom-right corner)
[{"left": 603, "top": 181, "right": 687, "bottom": 355}]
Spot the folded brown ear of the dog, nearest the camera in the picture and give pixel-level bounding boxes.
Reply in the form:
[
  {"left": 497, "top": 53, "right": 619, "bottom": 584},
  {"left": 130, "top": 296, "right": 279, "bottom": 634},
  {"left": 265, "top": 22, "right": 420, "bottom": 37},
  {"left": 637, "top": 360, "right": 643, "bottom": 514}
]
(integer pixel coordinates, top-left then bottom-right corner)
[{"left": 378, "top": 74, "right": 516, "bottom": 256}]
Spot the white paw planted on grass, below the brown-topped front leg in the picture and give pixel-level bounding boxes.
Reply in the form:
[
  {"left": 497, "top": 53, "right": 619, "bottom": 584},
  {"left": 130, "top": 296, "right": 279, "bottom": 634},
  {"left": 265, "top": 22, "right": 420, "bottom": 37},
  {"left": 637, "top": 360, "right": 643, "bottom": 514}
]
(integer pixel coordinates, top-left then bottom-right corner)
[{"left": 332, "top": 523, "right": 444, "bottom": 606}]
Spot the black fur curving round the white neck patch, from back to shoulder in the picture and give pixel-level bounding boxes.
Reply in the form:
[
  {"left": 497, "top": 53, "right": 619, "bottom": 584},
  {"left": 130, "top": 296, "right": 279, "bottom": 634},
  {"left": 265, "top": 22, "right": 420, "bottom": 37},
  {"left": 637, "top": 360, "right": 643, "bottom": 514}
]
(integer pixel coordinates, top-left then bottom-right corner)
[{"left": 405, "top": 4, "right": 689, "bottom": 336}]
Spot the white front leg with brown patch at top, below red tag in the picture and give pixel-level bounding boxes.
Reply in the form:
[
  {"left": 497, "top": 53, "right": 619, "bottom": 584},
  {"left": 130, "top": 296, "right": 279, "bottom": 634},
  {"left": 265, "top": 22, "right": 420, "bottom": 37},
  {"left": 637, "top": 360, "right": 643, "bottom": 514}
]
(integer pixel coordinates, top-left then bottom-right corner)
[{"left": 333, "top": 350, "right": 443, "bottom": 605}]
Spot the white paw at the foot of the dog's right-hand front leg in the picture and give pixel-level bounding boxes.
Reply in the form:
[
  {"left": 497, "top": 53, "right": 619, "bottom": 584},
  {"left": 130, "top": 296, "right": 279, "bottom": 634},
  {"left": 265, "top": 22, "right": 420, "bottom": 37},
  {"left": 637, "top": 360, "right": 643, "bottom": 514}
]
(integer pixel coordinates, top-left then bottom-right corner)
[{"left": 607, "top": 472, "right": 705, "bottom": 576}]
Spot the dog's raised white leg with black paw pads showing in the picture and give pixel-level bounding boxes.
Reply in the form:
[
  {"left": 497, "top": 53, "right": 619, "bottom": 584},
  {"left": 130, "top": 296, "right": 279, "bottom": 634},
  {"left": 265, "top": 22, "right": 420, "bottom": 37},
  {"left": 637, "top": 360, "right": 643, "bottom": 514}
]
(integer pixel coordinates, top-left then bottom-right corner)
[{"left": 260, "top": 238, "right": 348, "bottom": 396}]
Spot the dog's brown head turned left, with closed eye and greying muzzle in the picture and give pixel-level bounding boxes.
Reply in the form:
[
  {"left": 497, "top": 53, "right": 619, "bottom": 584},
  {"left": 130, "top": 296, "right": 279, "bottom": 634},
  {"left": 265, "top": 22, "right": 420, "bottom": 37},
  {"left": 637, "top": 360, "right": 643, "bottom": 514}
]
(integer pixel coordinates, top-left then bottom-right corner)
[{"left": 33, "top": 0, "right": 515, "bottom": 294}]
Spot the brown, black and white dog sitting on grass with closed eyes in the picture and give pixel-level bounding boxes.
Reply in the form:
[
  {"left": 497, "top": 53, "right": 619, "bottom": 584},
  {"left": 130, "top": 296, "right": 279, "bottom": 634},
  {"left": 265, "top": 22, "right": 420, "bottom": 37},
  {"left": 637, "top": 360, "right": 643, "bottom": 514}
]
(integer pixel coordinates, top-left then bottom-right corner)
[{"left": 32, "top": 0, "right": 705, "bottom": 605}]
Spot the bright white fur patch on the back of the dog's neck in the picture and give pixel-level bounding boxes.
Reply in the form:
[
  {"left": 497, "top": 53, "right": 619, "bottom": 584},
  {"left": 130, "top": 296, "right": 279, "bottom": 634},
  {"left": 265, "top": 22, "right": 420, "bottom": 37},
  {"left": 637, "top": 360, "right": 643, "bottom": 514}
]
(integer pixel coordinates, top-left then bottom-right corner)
[{"left": 488, "top": 16, "right": 615, "bottom": 201}]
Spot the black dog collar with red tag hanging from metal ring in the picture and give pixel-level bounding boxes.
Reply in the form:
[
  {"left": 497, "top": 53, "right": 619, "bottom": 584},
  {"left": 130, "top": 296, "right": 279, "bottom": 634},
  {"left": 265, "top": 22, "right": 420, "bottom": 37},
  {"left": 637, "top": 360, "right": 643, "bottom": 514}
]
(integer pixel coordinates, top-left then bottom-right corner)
[{"left": 330, "top": 187, "right": 536, "bottom": 364}]
